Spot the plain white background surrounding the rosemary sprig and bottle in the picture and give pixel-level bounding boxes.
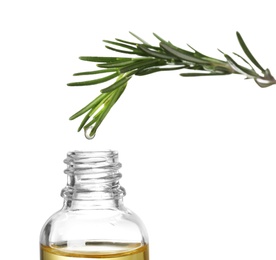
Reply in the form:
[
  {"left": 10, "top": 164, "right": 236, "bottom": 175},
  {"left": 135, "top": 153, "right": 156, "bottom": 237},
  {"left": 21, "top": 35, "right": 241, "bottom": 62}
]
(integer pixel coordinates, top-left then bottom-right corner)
[{"left": 0, "top": 0, "right": 276, "bottom": 260}]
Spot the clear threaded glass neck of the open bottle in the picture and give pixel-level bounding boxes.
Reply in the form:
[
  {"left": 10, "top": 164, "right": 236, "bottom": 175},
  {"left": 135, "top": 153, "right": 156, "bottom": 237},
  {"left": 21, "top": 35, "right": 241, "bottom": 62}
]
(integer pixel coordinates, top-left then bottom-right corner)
[{"left": 61, "top": 151, "right": 125, "bottom": 208}]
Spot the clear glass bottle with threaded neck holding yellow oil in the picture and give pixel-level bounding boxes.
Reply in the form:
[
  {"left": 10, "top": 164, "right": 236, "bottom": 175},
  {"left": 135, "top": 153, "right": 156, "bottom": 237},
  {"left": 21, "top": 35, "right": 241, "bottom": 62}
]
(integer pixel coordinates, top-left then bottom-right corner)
[{"left": 40, "top": 151, "right": 149, "bottom": 260}]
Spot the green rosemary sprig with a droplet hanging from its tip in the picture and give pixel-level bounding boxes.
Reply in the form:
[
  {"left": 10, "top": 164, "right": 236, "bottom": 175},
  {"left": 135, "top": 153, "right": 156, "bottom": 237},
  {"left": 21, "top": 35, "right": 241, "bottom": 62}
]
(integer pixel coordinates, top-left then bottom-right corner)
[{"left": 68, "top": 32, "right": 276, "bottom": 139}]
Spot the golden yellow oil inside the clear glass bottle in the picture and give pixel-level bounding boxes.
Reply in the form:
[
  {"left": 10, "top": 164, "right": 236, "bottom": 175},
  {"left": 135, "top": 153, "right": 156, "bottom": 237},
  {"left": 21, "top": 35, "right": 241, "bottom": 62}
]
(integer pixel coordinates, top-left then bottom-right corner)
[{"left": 40, "top": 242, "right": 149, "bottom": 260}]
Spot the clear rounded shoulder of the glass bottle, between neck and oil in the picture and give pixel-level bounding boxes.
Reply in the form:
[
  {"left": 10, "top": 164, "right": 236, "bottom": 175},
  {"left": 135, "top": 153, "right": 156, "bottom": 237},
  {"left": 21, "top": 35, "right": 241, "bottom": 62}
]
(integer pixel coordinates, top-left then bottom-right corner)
[{"left": 40, "top": 206, "right": 148, "bottom": 245}]
